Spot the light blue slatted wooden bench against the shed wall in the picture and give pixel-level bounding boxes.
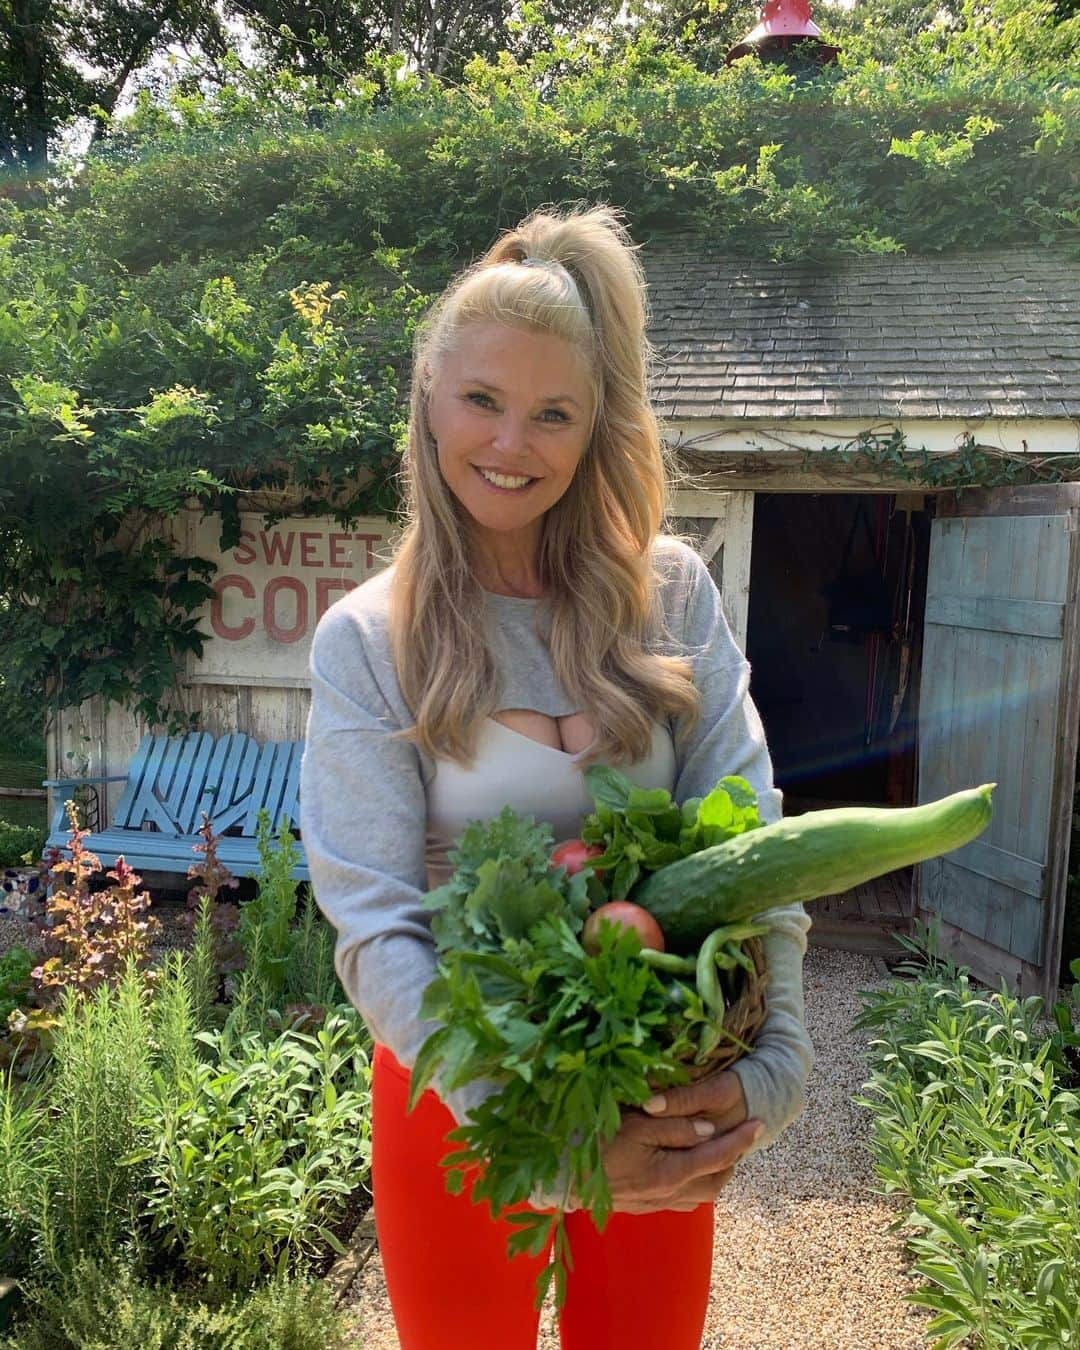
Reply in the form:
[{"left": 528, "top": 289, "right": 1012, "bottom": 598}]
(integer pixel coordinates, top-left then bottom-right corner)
[{"left": 43, "top": 732, "right": 309, "bottom": 882}]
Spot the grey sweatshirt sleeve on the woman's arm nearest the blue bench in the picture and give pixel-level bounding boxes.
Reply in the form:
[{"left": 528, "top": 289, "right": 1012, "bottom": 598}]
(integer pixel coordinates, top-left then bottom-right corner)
[{"left": 300, "top": 605, "right": 494, "bottom": 1125}]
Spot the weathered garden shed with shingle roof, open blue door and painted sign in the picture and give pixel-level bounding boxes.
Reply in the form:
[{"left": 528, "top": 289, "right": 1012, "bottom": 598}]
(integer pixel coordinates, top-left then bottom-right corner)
[{"left": 49, "top": 238, "right": 1080, "bottom": 992}]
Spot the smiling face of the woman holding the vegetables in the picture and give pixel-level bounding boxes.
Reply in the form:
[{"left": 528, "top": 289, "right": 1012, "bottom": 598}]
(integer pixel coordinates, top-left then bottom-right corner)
[{"left": 428, "top": 323, "right": 593, "bottom": 580}]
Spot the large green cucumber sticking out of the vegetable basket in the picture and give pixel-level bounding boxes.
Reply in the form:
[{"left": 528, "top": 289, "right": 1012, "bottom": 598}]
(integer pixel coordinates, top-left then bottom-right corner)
[{"left": 626, "top": 783, "right": 998, "bottom": 952}]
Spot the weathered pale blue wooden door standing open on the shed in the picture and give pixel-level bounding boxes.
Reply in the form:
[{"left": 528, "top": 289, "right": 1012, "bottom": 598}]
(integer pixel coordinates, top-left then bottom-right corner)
[{"left": 915, "top": 483, "right": 1080, "bottom": 996}]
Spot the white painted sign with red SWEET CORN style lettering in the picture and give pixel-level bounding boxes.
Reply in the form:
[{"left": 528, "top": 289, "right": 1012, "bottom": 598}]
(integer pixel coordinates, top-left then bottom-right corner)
[{"left": 189, "top": 513, "right": 396, "bottom": 686}]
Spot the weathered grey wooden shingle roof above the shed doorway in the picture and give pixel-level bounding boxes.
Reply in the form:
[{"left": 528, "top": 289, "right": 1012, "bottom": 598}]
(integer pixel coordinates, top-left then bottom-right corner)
[{"left": 640, "top": 238, "right": 1080, "bottom": 420}]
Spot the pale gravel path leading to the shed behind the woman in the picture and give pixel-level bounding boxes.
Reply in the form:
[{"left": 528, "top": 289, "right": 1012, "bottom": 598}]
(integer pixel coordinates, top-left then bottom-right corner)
[{"left": 350, "top": 948, "right": 930, "bottom": 1350}]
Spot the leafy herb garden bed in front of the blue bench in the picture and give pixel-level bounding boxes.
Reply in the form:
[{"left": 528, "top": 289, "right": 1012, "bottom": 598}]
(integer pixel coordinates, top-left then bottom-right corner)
[{"left": 0, "top": 818, "right": 371, "bottom": 1350}]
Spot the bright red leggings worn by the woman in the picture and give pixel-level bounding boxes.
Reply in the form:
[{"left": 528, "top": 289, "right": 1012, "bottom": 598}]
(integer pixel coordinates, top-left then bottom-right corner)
[{"left": 371, "top": 1045, "right": 713, "bottom": 1350}]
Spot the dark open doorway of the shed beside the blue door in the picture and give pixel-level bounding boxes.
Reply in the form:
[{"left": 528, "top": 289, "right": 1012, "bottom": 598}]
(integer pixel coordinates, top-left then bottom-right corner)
[{"left": 747, "top": 493, "right": 933, "bottom": 815}]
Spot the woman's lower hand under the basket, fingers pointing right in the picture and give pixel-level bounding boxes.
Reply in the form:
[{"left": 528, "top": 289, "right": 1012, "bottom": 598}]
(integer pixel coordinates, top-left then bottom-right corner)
[{"left": 601, "top": 1106, "right": 763, "bottom": 1214}]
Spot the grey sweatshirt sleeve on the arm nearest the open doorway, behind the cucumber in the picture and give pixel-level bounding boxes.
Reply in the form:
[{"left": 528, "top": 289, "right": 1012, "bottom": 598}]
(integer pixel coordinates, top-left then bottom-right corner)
[{"left": 674, "top": 549, "right": 814, "bottom": 1149}]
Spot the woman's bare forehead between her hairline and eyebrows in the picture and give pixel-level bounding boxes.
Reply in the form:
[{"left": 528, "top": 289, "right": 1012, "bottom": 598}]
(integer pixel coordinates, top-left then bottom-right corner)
[{"left": 437, "top": 323, "right": 591, "bottom": 401}]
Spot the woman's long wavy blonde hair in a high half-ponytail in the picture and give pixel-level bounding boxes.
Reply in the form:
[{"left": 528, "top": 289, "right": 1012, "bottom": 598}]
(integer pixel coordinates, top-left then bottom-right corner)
[{"left": 390, "top": 207, "right": 699, "bottom": 765}]
